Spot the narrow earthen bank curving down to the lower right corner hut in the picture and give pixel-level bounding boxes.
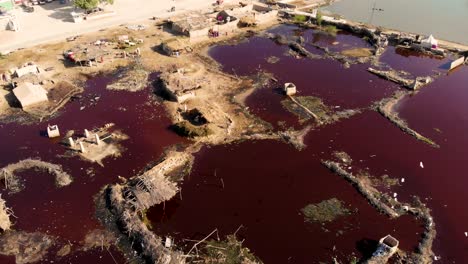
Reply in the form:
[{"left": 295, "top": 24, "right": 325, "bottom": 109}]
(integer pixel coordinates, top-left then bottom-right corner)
[{"left": 322, "top": 160, "right": 436, "bottom": 263}]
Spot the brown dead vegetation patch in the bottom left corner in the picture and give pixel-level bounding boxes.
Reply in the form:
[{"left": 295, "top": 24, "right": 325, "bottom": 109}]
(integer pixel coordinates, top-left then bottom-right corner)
[{"left": 0, "top": 231, "right": 54, "bottom": 264}]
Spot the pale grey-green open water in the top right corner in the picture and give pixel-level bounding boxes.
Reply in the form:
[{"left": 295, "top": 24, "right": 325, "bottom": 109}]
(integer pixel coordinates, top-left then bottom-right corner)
[{"left": 325, "top": 0, "right": 468, "bottom": 44}]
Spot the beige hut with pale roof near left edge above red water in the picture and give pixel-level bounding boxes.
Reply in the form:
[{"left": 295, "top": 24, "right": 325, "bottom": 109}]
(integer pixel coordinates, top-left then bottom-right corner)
[{"left": 13, "top": 82, "right": 48, "bottom": 109}]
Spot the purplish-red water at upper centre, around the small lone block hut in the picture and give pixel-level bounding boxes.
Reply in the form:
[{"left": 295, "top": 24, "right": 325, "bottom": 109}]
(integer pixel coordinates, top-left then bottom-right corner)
[{"left": 210, "top": 26, "right": 397, "bottom": 129}]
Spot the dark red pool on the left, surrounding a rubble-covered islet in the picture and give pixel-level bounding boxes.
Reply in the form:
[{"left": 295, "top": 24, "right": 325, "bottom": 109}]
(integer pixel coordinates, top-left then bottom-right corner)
[{"left": 0, "top": 72, "right": 184, "bottom": 263}]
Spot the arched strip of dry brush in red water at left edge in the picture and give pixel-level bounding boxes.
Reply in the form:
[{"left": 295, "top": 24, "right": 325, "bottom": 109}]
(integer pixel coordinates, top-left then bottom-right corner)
[{"left": 0, "top": 159, "right": 73, "bottom": 193}]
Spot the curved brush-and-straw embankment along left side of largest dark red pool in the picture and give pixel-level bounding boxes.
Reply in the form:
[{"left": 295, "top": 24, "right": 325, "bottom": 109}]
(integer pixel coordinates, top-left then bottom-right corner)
[{"left": 101, "top": 151, "right": 193, "bottom": 264}]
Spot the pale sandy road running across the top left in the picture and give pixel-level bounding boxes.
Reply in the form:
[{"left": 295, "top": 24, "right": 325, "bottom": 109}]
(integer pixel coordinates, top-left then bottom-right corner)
[{"left": 0, "top": 0, "right": 227, "bottom": 52}]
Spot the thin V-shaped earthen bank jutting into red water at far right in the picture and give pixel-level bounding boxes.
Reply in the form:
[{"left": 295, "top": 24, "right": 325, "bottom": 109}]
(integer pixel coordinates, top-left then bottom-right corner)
[{"left": 376, "top": 91, "right": 440, "bottom": 148}]
